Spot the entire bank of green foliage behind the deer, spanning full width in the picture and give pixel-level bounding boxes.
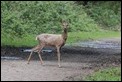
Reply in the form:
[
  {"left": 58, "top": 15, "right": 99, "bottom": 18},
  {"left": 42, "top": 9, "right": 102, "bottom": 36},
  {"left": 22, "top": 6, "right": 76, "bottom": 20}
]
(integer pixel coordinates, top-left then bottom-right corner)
[{"left": 1, "top": 1, "right": 121, "bottom": 45}]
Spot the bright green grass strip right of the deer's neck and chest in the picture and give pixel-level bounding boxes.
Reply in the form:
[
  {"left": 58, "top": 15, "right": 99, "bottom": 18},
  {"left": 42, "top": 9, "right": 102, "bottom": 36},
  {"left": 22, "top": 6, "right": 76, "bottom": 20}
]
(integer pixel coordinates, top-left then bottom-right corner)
[{"left": 67, "top": 31, "right": 121, "bottom": 43}]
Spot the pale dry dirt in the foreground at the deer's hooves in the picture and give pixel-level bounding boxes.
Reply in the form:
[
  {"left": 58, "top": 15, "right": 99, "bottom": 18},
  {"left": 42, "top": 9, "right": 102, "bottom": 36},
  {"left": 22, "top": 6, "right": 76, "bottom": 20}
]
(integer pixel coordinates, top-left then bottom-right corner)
[{"left": 1, "top": 61, "right": 92, "bottom": 81}]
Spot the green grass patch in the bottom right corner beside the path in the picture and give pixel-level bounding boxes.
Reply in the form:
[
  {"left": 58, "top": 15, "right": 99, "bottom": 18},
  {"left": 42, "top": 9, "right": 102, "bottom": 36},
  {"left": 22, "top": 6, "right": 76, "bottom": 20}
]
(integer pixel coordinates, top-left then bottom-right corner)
[{"left": 85, "top": 67, "right": 121, "bottom": 81}]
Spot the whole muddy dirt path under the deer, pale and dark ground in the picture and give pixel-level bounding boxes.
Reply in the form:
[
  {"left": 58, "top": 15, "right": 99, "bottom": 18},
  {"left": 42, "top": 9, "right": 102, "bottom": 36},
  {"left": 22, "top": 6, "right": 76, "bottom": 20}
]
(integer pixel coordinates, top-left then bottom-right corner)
[{"left": 1, "top": 39, "right": 121, "bottom": 81}]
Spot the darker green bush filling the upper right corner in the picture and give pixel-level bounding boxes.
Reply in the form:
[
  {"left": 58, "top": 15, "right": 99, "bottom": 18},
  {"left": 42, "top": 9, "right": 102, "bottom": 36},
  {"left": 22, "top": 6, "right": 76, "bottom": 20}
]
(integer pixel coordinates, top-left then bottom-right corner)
[{"left": 86, "top": 1, "right": 121, "bottom": 30}]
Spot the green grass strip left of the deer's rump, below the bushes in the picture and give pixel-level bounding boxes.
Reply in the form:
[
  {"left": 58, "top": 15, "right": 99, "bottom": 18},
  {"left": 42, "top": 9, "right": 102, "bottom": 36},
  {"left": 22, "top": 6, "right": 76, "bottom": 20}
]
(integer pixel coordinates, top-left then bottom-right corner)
[{"left": 1, "top": 35, "right": 38, "bottom": 47}]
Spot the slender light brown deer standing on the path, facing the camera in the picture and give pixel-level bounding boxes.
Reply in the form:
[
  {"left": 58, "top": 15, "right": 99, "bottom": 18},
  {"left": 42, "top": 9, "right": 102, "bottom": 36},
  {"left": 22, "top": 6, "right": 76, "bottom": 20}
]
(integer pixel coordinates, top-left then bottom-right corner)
[{"left": 28, "top": 21, "right": 68, "bottom": 67}]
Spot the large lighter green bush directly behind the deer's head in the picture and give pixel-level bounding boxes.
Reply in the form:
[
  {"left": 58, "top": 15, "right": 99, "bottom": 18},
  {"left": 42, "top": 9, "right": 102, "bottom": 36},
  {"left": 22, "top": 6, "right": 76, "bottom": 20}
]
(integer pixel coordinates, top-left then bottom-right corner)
[{"left": 1, "top": 1, "right": 98, "bottom": 37}]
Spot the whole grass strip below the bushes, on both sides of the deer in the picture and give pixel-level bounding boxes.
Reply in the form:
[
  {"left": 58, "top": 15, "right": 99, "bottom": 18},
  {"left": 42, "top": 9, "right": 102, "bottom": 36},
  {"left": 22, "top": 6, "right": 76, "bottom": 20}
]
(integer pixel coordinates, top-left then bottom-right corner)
[{"left": 1, "top": 31, "right": 121, "bottom": 47}]
